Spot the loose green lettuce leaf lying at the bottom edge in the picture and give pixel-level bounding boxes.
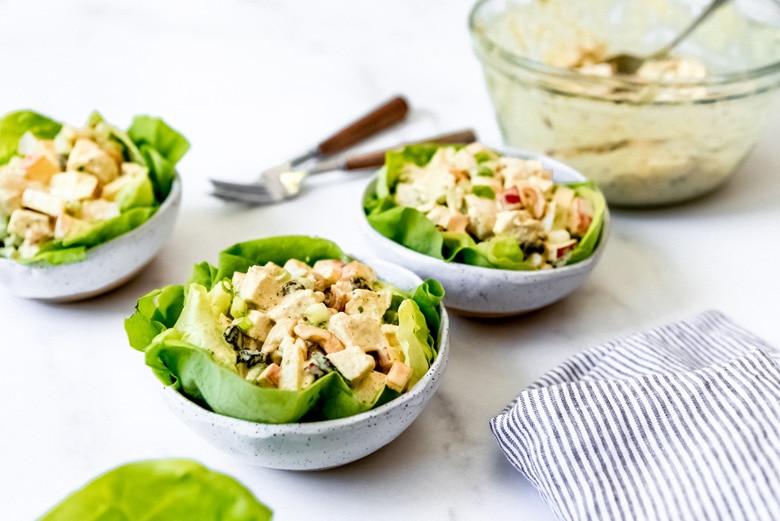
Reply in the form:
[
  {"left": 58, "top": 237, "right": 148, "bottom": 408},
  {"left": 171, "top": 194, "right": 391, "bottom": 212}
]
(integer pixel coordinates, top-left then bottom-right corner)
[{"left": 39, "top": 459, "right": 272, "bottom": 521}]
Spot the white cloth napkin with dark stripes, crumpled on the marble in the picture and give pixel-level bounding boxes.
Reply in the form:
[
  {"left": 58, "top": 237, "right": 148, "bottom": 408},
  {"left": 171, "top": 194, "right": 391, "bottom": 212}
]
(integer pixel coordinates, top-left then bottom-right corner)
[{"left": 490, "top": 311, "right": 780, "bottom": 521}]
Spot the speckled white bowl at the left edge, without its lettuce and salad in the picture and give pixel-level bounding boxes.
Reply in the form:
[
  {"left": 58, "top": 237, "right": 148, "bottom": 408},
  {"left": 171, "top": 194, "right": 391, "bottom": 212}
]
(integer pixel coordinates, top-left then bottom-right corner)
[{"left": 0, "top": 176, "right": 182, "bottom": 302}]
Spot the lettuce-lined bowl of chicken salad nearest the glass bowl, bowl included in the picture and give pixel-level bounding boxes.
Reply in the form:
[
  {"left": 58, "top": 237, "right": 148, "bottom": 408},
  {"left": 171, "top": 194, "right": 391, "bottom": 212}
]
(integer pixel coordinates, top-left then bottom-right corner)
[{"left": 360, "top": 143, "right": 609, "bottom": 317}]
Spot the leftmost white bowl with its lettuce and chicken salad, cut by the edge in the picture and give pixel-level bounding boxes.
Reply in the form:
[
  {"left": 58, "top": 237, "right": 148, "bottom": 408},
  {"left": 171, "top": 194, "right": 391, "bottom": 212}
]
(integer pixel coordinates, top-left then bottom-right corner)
[{"left": 0, "top": 107, "right": 189, "bottom": 301}]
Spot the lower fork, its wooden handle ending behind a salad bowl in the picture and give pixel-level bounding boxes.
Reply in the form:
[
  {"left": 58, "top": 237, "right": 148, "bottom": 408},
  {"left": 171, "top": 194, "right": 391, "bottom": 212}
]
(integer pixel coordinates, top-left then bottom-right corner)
[{"left": 212, "top": 129, "right": 477, "bottom": 204}]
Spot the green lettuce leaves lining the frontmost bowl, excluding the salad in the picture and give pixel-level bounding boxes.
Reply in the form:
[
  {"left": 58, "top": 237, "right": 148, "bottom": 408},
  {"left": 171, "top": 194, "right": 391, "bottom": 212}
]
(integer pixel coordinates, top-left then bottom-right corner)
[{"left": 125, "top": 236, "right": 444, "bottom": 423}]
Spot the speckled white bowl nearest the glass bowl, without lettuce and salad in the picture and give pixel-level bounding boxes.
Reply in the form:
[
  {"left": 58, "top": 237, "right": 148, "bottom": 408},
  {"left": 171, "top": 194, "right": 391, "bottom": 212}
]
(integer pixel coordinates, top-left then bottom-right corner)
[{"left": 358, "top": 150, "right": 609, "bottom": 318}]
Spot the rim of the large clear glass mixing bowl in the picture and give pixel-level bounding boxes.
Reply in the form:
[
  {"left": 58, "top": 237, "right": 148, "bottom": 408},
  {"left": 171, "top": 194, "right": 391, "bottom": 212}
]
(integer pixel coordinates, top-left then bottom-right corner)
[{"left": 468, "top": 0, "right": 780, "bottom": 88}]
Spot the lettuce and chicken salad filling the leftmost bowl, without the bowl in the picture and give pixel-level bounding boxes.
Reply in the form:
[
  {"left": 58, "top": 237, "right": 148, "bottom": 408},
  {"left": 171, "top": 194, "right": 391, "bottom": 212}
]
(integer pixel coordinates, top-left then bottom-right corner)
[{"left": 0, "top": 110, "right": 190, "bottom": 264}]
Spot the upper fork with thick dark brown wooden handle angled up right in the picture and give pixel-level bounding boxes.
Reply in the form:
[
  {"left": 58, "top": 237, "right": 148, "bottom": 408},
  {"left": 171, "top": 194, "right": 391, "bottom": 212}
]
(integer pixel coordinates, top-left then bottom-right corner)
[{"left": 211, "top": 96, "right": 409, "bottom": 203}]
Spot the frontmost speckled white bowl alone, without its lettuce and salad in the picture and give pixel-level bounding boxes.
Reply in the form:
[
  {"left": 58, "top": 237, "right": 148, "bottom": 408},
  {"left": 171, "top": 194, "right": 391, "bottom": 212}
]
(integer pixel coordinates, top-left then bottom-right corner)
[{"left": 162, "top": 259, "right": 449, "bottom": 470}]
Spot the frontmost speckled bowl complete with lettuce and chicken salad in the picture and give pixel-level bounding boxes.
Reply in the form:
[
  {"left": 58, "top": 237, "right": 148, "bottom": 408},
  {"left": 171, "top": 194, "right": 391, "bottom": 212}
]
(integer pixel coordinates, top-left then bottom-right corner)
[{"left": 125, "top": 236, "right": 449, "bottom": 470}]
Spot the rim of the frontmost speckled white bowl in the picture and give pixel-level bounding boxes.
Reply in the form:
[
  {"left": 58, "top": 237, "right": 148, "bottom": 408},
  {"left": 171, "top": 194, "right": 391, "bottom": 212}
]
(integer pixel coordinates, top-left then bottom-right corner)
[{"left": 162, "top": 257, "right": 450, "bottom": 436}]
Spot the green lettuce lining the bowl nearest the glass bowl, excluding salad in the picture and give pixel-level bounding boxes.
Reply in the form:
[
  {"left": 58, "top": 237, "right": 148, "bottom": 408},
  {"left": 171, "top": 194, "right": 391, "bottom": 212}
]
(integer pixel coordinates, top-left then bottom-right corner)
[{"left": 363, "top": 144, "right": 607, "bottom": 270}]
